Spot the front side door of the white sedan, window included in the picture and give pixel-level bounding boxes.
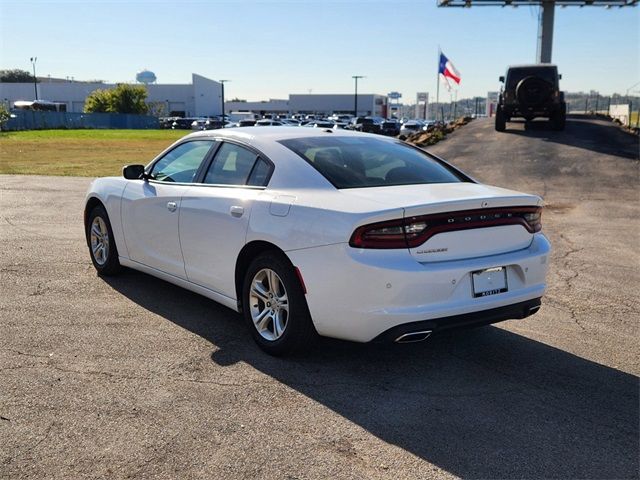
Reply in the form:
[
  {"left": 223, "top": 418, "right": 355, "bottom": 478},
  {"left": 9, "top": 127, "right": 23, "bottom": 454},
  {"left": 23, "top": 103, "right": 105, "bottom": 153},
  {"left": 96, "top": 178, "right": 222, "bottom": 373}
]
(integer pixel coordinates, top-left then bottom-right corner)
[{"left": 122, "top": 140, "right": 216, "bottom": 279}]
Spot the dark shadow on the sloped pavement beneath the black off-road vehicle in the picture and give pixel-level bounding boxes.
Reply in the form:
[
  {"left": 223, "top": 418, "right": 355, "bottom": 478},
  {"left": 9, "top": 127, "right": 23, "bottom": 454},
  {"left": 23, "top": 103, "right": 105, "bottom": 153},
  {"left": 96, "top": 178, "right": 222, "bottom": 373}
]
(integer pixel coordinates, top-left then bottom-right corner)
[{"left": 505, "top": 116, "right": 640, "bottom": 160}]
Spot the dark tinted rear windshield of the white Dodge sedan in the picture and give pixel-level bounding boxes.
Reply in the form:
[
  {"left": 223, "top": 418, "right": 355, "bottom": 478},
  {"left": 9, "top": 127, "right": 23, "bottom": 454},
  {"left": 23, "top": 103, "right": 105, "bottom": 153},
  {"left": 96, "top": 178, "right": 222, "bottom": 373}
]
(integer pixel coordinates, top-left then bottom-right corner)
[{"left": 280, "top": 136, "right": 466, "bottom": 188}]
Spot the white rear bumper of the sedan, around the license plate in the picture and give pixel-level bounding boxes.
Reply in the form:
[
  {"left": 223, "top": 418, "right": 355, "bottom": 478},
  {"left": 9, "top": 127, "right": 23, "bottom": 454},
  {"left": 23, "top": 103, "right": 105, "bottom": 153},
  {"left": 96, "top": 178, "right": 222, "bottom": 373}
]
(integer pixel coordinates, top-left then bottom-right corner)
[{"left": 286, "top": 233, "right": 550, "bottom": 342}]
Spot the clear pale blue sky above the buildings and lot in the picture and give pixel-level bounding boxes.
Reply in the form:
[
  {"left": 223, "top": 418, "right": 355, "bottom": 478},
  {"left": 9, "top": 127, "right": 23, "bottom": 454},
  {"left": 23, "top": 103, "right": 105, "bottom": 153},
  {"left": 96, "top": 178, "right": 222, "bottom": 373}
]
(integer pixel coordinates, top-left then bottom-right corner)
[{"left": 0, "top": 0, "right": 640, "bottom": 103}]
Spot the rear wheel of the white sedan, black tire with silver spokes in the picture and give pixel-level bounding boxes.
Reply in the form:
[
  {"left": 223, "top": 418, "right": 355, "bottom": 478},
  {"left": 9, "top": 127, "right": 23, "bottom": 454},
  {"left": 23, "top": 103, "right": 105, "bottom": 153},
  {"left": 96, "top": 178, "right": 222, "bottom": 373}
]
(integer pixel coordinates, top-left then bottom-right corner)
[{"left": 242, "top": 251, "right": 318, "bottom": 356}]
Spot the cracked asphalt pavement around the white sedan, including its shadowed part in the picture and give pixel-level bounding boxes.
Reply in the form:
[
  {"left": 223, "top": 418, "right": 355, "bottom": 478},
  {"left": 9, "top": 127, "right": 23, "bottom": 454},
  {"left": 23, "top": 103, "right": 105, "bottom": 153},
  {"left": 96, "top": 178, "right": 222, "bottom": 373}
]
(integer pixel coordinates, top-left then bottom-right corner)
[{"left": 0, "top": 118, "right": 640, "bottom": 479}]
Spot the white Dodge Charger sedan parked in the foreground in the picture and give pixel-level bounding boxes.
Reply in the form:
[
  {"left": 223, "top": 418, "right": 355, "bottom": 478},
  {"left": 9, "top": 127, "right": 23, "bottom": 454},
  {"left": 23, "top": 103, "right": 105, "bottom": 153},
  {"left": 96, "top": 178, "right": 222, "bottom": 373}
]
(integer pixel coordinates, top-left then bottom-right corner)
[{"left": 84, "top": 127, "right": 550, "bottom": 355}]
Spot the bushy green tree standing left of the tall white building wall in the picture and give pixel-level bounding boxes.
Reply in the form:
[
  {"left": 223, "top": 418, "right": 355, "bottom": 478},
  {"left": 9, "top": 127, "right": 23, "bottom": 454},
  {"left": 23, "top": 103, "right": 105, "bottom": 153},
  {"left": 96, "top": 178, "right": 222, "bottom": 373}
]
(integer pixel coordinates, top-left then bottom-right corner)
[{"left": 84, "top": 83, "right": 149, "bottom": 114}]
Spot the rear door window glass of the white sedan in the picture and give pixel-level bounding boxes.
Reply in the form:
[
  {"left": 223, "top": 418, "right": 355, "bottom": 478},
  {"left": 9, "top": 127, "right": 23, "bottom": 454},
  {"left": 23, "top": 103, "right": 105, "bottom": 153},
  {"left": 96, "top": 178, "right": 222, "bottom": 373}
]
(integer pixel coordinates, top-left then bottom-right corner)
[{"left": 204, "top": 142, "right": 258, "bottom": 185}]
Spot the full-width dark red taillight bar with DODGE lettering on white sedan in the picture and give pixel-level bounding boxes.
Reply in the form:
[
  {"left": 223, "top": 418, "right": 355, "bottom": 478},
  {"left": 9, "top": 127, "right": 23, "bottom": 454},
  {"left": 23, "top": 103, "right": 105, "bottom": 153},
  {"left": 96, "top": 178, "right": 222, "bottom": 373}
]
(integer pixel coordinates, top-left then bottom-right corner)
[{"left": 349, "top": 207, "right": 542, "bottom": 248}]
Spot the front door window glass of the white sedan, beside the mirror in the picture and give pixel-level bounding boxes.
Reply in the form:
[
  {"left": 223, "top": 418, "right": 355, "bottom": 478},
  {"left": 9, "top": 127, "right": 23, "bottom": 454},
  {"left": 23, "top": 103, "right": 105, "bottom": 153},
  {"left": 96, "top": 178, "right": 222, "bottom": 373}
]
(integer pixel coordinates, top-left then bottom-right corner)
[{"left": 149, "top": 140, "right": 213, "bottom": 183}]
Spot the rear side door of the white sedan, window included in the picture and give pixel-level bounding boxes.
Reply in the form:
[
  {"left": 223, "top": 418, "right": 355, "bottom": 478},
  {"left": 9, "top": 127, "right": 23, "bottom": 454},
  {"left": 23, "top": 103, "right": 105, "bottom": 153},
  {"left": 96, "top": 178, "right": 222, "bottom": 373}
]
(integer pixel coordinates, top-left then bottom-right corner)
[{"left": 180, "top": 141, "right": 273, "bottom": 298}]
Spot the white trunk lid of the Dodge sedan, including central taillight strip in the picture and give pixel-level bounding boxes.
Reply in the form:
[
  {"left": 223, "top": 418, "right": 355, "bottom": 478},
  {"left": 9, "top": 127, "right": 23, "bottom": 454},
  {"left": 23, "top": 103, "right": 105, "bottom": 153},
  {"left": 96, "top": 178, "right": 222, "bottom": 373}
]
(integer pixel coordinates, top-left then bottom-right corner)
[{"left": 343, "top": 183, "right": 542, "bottom": 262}]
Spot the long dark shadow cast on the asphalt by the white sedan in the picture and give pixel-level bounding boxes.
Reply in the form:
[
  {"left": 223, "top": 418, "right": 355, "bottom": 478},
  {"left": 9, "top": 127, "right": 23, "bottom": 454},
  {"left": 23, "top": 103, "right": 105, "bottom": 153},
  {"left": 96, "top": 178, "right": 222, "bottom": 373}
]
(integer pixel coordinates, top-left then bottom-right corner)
[{"left": 105, "top": 270, "right": 639, "bottom": 478}]
